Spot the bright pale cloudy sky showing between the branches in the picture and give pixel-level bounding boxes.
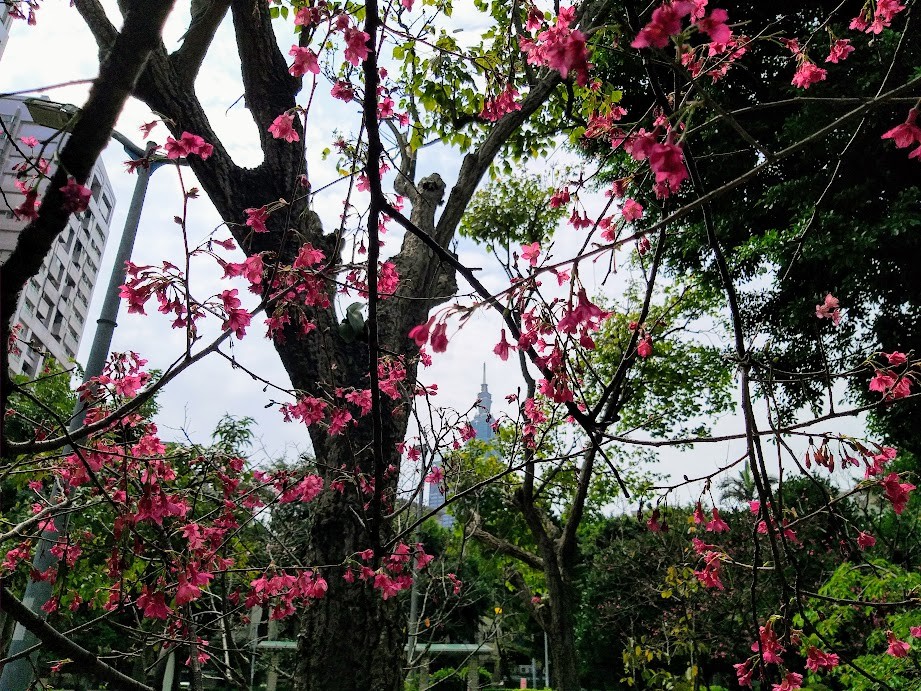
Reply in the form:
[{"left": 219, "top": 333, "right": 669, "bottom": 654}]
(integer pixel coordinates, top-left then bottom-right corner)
[{"left": 0, "top": 2, "right": 868, "bottom": 506}]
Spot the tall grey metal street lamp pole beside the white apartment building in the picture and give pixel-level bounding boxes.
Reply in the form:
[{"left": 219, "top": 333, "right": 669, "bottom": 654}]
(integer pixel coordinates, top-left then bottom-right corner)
[{"left": 0, "top": 137, "right": 172, "bottom": 691}]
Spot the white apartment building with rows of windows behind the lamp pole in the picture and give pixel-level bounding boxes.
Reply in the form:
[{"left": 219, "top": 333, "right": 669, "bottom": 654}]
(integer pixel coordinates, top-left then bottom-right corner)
[{"left": 0, "top": 93, "right": 115, "bottom": 376}]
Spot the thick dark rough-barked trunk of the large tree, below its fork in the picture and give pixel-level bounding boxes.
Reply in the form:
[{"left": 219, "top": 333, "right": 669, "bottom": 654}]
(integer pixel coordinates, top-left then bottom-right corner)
[{"left": 268, "top": 207, "right": 453, "bottom": 691}]
